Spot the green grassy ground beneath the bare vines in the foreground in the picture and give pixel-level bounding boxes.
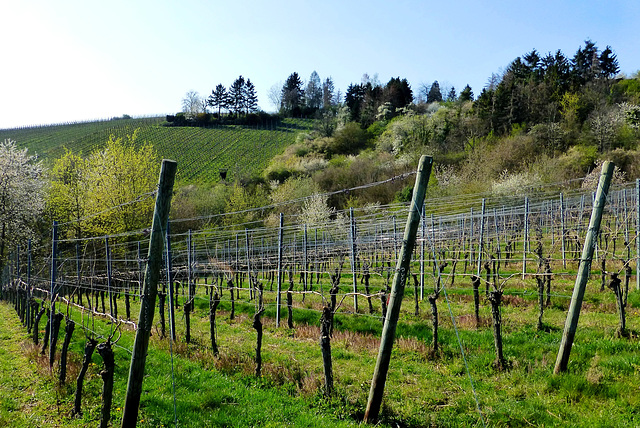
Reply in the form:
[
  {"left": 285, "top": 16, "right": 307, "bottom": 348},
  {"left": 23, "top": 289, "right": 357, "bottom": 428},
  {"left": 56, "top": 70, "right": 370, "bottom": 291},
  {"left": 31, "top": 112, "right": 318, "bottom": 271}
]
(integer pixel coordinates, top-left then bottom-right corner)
[{"left": 0, "top": 266, "right": 640, "bottom": 427}]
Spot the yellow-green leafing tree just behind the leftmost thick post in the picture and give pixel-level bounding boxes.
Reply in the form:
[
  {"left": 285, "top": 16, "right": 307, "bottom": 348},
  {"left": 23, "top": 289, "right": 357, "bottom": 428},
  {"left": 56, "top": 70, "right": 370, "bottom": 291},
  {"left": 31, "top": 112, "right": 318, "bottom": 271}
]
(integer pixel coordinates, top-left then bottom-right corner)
[{"left": 85, "top": 132, "right": 160, "bottom": 235}]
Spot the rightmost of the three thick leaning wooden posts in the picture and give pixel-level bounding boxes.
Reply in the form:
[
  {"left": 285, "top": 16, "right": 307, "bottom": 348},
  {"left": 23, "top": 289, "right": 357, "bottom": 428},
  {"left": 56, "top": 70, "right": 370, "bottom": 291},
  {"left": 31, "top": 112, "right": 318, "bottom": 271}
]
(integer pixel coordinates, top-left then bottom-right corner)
[{"left": 553, "top": 161, "right": 614, "bottom": 374}]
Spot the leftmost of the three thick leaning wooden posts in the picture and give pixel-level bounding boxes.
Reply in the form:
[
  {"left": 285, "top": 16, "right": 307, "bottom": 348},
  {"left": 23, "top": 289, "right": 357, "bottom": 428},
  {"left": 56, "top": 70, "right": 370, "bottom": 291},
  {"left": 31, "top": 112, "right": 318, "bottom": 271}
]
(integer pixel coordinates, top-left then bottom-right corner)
[{"left": 121, "top": 159, "right": 178, "bottom": 428}]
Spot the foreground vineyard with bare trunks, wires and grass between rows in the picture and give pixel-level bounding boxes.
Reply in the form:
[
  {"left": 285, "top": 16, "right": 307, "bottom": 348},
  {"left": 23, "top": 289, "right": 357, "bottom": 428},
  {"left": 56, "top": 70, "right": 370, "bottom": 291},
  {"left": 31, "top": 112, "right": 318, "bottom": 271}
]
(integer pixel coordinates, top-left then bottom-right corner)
[{"left": 0, "top": 159, "right": 640, "bottom": 427}]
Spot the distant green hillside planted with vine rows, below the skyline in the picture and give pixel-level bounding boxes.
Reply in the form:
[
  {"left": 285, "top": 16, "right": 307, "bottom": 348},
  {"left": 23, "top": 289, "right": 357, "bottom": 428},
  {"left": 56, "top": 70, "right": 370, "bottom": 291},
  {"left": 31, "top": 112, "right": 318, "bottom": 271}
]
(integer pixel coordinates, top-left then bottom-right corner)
[{"left": 0, "top": 117, "right": 311, "bottom": 184}]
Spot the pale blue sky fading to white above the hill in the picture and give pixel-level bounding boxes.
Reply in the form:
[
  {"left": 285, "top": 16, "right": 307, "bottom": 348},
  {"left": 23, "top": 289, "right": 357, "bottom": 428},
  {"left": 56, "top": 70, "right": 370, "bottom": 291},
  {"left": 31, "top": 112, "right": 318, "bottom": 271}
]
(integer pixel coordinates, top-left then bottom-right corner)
[{"left": 0, "top": 0, "right": 640, "bottom": 129}]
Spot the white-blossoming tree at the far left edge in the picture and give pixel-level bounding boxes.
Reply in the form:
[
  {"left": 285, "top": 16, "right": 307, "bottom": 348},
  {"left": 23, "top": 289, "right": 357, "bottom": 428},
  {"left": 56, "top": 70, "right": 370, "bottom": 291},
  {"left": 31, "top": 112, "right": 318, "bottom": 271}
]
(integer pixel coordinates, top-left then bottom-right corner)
[{"left": 0, "top": 140, "right": 44, "bottom": 272}]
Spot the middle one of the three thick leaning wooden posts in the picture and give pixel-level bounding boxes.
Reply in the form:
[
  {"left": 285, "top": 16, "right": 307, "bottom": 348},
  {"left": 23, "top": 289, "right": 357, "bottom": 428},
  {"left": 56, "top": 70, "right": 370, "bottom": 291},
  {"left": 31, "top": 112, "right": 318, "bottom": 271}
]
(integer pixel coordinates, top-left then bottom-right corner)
[{"left": 364, "top": 155, "right": 433, "bottom": 423}]
